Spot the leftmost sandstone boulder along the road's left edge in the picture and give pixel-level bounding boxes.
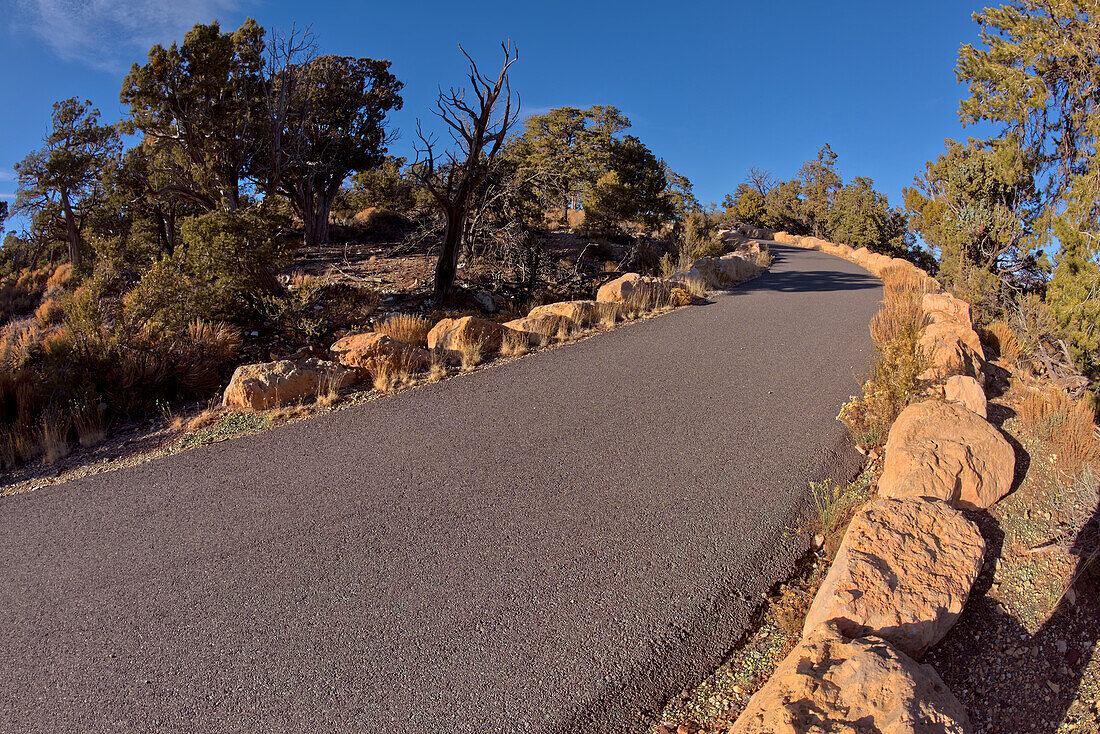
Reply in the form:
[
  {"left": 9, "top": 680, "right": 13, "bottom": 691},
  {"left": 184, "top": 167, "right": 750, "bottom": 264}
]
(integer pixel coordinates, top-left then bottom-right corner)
[{"left": 222, "top": 358, "right": 354, "bottom": 410}]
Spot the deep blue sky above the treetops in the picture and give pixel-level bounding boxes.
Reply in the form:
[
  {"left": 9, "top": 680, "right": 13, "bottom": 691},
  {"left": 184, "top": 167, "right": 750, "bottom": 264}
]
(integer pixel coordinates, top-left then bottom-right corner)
[{"left": 0, "top": 0, "right": 989, "bottom": 212}]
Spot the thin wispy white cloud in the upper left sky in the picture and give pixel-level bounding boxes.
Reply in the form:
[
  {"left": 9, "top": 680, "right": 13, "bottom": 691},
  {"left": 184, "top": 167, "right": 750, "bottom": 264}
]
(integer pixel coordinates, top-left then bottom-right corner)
[{"left": 18, "top": 0, "right": 244, "bottom": 72}]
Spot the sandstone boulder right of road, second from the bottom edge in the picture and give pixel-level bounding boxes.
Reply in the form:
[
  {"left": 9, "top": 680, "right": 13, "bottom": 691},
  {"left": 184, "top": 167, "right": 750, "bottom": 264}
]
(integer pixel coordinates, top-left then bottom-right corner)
[{"left": 802, "top": 497, "right": 986, "bottom": 658}]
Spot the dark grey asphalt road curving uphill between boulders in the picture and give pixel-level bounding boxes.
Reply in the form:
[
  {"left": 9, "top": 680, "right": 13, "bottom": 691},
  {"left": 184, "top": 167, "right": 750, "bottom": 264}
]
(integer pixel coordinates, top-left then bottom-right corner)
[{"left": 0, "top": 245, "right": 881, "bottom": 734}]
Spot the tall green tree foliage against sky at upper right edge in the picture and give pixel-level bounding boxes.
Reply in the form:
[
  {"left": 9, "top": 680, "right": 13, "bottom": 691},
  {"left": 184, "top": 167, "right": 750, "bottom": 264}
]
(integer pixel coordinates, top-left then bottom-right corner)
[{"left": 957, "top": 0, "right": 1100, "bottom": 371}]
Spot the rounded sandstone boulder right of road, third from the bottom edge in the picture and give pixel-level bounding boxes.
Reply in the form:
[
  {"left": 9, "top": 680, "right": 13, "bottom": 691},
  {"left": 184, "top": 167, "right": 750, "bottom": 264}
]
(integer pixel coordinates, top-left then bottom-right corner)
[{"left": 879, "top": 401, "right": 1015, "bottom": 510}]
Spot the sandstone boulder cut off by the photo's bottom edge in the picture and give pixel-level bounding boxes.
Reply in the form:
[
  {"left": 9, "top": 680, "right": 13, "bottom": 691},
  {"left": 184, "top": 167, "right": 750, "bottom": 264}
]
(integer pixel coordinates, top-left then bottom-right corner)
[{"left": 729, "top": 624, "right": 970, "bottom": 734}]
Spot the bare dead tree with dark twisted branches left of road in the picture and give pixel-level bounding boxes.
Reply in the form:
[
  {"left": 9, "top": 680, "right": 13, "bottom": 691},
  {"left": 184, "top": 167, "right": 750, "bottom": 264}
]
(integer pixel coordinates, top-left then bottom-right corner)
[{"left": 414, "top": 43, "right": 519, "bottom": 305}]
